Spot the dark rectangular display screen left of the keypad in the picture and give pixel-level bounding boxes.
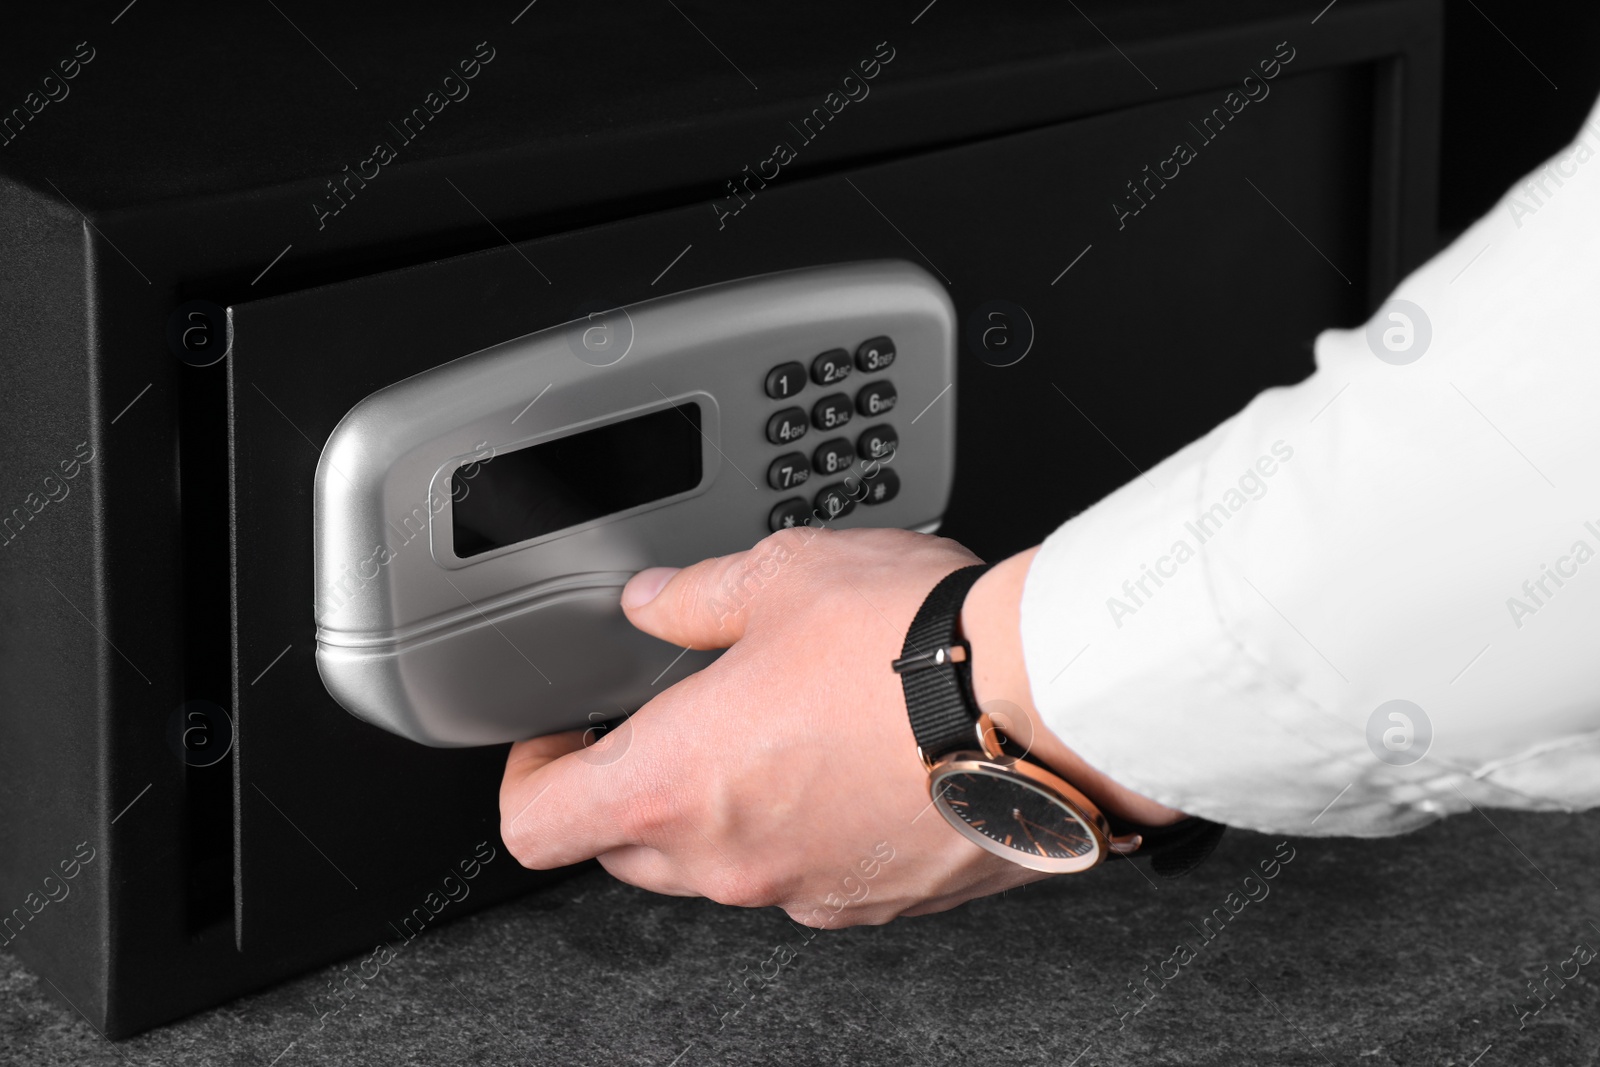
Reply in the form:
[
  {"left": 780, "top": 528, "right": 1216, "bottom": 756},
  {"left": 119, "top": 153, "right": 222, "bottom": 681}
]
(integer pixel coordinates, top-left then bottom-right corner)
[{"left": 451, "top": 403, "right": 701, "bottom": 560}]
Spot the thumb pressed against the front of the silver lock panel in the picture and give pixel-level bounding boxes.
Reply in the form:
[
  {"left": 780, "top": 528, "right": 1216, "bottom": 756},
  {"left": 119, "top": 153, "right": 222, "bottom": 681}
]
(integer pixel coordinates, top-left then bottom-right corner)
[{"left": 622, "top": 528, "right": 827, "bottom": 648}]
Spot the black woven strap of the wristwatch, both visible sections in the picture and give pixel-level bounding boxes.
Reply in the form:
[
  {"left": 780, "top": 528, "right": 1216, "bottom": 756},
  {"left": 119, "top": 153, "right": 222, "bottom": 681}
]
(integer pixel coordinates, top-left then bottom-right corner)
[{"left": 894, "top": 563, "right": 1227, "bottom": 878}]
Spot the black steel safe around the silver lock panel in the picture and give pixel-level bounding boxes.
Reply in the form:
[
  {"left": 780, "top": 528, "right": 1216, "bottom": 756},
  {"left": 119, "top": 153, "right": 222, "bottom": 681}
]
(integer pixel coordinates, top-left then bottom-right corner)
[{"left": 0, "top": 0, "right": 1440, "bottom": 1037}]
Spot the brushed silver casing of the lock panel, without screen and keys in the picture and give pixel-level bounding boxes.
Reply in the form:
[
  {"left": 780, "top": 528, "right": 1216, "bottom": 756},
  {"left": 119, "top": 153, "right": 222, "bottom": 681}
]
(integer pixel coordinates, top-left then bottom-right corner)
[{"left": 315, "top": 261, "right": 955, "bottom": 747}]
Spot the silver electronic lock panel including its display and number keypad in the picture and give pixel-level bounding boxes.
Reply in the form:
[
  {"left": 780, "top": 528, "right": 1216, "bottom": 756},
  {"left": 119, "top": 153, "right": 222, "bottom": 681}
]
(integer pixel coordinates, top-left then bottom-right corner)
[{"left": 315, "top": 261, "right": 955, "bottom": 745}]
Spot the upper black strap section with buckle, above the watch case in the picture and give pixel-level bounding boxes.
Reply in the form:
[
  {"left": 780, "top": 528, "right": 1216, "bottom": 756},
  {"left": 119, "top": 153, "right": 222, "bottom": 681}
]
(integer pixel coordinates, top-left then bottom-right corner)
[{"left": 894, "top": 563, "right": 994, "bottom": 761}]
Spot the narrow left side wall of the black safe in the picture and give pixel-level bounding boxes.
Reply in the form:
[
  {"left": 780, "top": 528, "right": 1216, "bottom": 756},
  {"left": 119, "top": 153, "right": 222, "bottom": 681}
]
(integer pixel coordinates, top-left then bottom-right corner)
[{"left": 0, "top": 179, "right": 109, "bottom": 1021}]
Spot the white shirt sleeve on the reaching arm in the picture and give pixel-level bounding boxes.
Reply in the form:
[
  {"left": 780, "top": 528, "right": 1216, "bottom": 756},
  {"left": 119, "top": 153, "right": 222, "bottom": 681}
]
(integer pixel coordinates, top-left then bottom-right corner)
[{"left": 1022, "top": 95, "right": 1600, "bottom": 837}]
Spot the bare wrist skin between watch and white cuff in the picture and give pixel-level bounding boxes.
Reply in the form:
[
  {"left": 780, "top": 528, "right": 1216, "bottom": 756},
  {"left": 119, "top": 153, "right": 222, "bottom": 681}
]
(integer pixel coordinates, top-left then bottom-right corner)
[{"left": 962, "top": 547, "right": 1184, "bottom": 825}]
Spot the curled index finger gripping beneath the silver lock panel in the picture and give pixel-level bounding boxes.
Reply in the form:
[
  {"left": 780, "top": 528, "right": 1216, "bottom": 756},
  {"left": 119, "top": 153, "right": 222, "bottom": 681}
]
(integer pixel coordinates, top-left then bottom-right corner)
[{"left": 499, "top": 731, "right": 634, "bottom": 870}]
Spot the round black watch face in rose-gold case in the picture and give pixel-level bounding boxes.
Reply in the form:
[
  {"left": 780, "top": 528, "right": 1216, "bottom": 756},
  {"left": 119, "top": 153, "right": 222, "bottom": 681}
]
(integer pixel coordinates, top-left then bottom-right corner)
[{"left": 928, "top": 758, "right": 1101, "bottom": 873}]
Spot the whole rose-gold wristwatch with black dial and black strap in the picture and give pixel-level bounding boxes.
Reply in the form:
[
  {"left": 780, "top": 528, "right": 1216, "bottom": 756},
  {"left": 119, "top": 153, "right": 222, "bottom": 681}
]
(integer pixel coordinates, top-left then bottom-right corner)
[{"left": 891, "top": 563, "right": 1226, "bottom": 877}]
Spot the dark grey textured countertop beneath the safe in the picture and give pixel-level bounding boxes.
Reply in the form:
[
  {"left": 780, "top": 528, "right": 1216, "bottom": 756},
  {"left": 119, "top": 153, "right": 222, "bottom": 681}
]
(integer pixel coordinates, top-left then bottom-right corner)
[{"left": 0, "top": 813, "right": 1600, "bottom": 1067}]
